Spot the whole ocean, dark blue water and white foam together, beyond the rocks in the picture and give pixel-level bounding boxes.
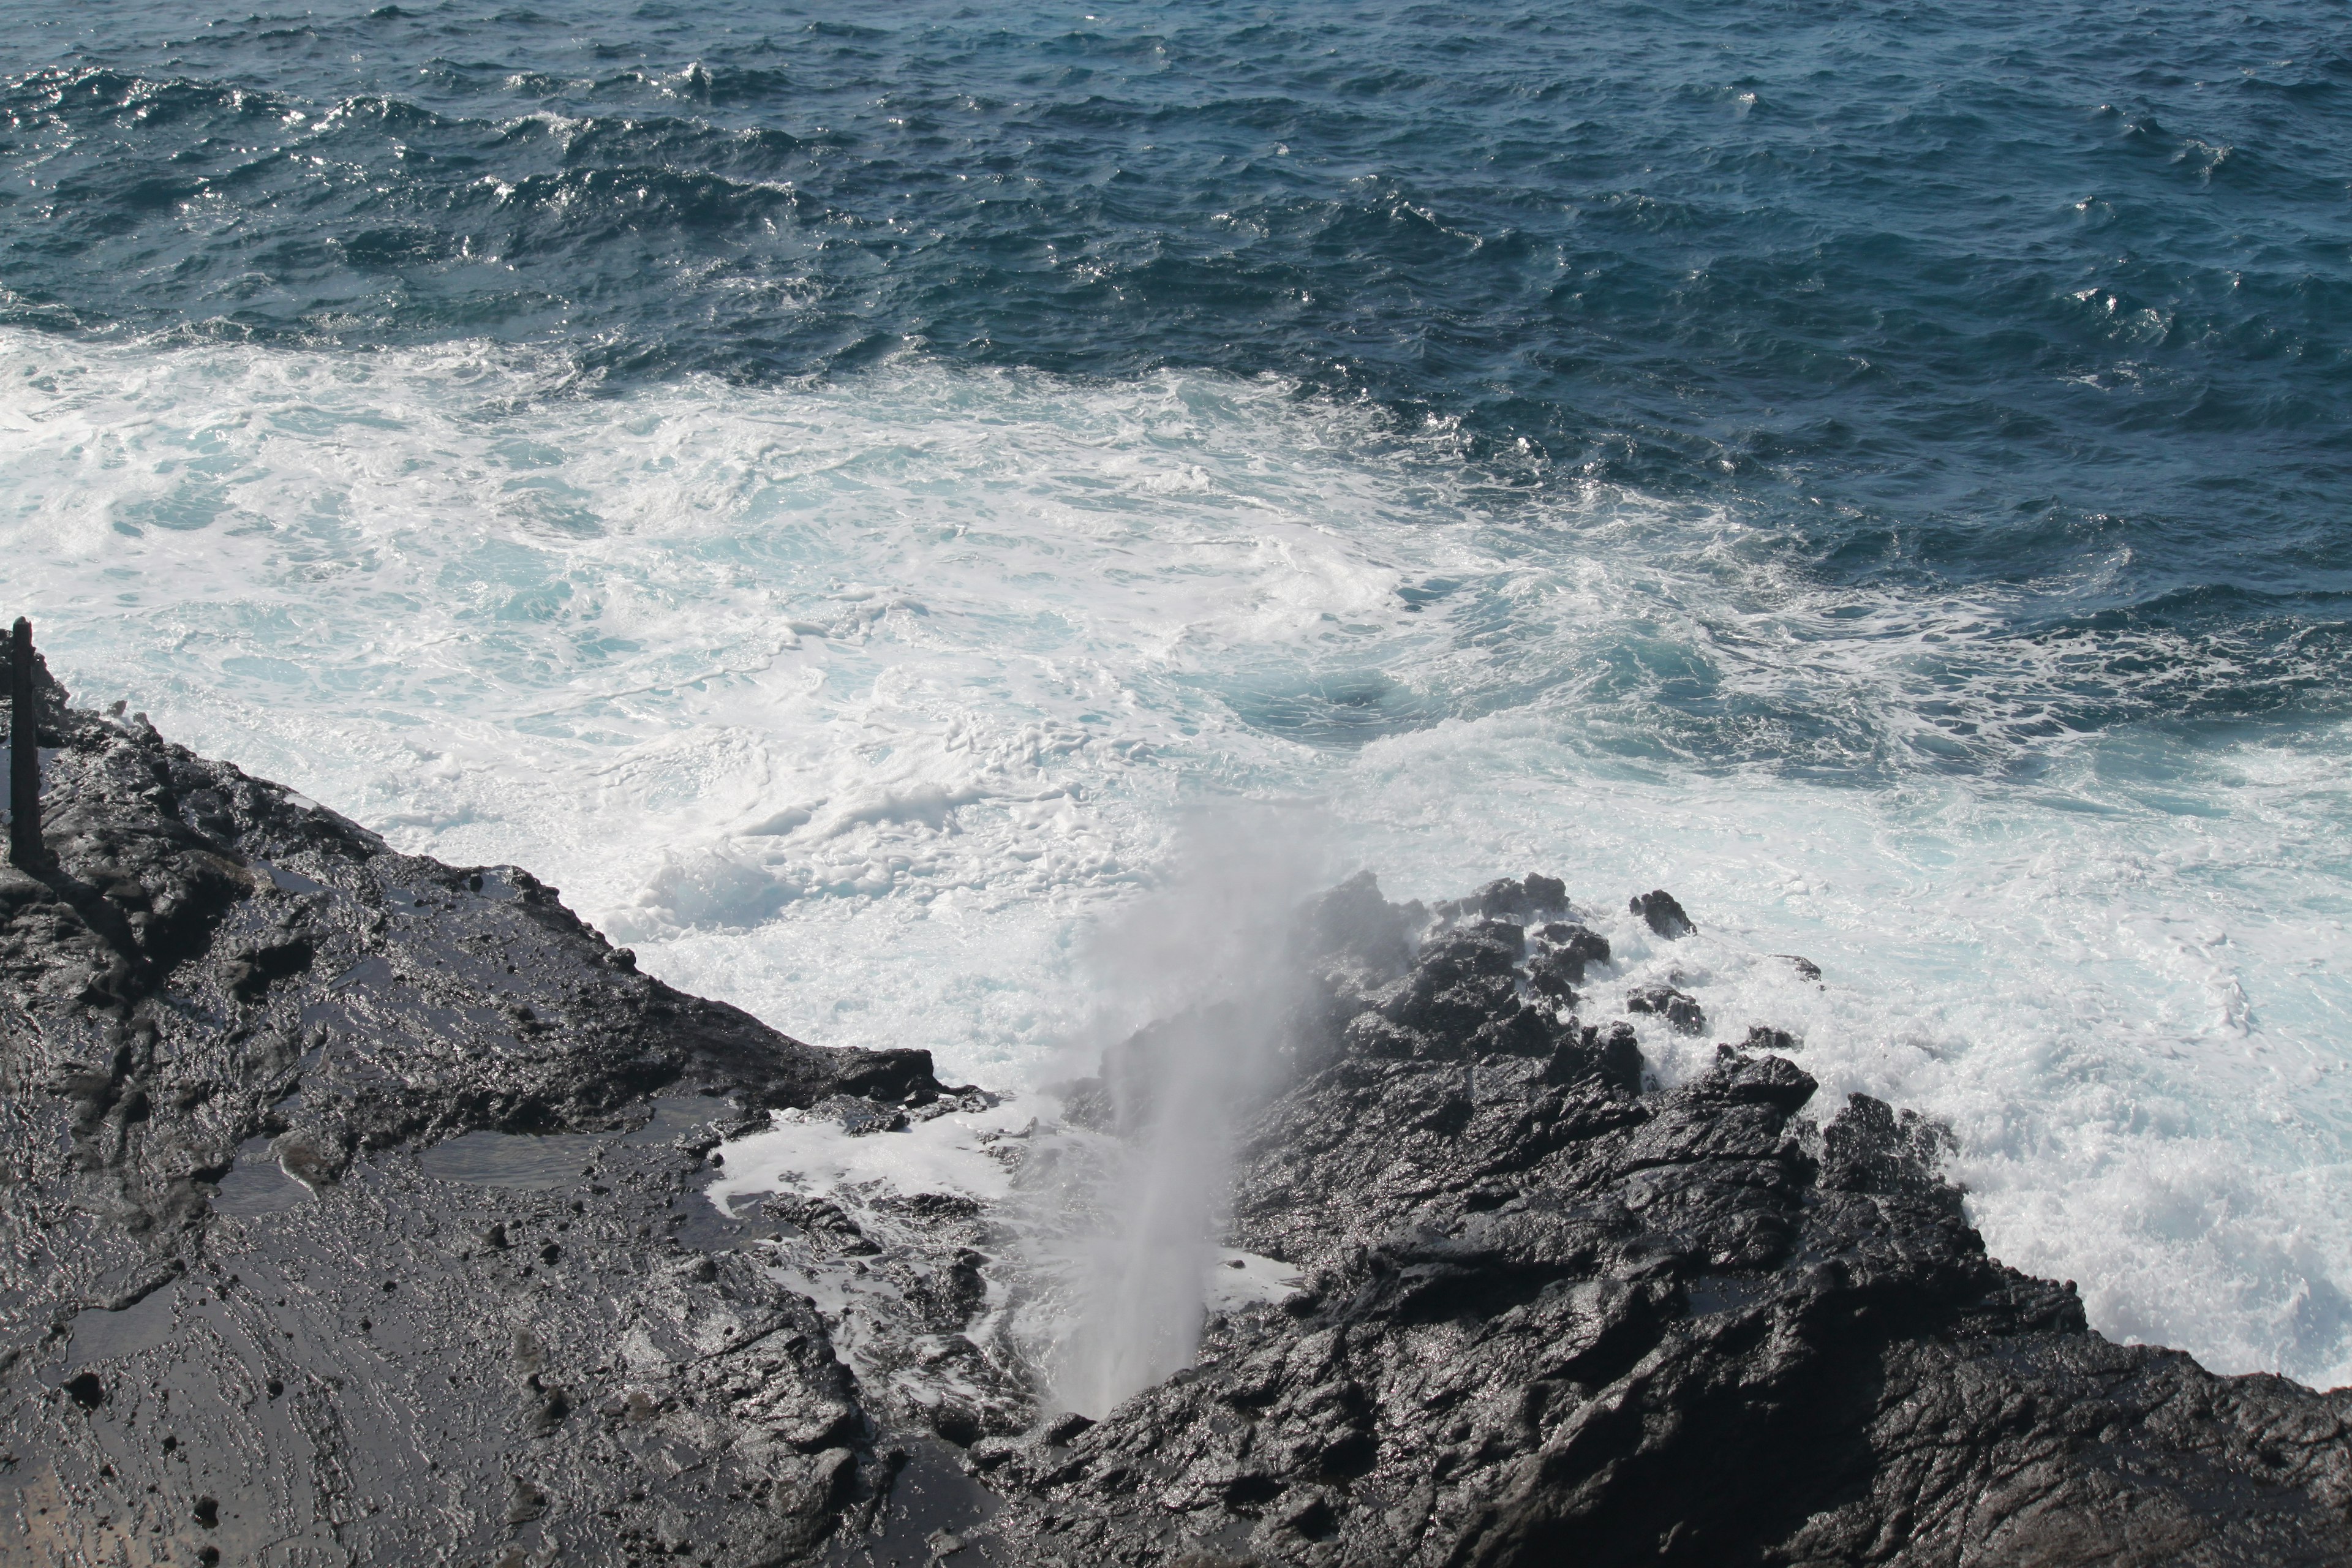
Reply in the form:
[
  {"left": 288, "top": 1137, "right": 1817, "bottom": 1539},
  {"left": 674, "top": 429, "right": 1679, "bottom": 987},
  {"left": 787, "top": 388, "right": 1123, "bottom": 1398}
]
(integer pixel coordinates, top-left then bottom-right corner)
[{"left": 0, "top": 0, "right": 2352, "bottom": 1385}]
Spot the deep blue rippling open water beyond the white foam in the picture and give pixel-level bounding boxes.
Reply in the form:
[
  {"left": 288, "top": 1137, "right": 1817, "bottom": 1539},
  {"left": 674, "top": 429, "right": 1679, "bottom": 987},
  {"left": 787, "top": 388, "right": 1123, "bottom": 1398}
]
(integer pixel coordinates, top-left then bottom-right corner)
[{"left": 0, "top": 0, "right": 2352, "bottom": 752}]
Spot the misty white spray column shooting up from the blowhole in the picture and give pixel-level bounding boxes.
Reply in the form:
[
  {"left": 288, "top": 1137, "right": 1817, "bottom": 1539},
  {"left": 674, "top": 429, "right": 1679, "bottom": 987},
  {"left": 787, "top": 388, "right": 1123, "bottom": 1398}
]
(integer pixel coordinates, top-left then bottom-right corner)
[{"left": 1033, "top": 806, "right": 1324, "bottom": 1417}]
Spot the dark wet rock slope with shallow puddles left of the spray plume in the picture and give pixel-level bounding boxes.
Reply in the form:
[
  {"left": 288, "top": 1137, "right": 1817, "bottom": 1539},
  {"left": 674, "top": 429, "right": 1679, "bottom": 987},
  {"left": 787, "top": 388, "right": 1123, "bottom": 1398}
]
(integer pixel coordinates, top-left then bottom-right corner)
[{"left": 0, "top": 639, "right": 938, "bottom": 1566}]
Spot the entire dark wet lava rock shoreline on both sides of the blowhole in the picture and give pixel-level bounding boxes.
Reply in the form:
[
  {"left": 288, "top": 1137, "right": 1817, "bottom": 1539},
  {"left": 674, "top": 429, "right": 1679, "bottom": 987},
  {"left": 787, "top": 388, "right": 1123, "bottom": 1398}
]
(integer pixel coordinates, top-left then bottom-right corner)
[{"left": 0, "top": 658, "right": 2352, "bottom": 1568}]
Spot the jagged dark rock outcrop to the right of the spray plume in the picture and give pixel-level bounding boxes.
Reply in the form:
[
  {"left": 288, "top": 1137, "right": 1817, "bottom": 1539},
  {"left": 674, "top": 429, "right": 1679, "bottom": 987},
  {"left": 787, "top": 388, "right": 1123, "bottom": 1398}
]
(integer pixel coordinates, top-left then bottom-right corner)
[{"left": 971, "top": 877, "right": 2352, "bottom": 1568}]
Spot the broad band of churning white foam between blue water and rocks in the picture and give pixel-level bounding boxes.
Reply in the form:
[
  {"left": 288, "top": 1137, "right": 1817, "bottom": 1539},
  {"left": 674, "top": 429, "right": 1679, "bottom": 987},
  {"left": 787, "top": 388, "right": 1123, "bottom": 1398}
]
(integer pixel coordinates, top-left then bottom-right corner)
[{"left": 0, "top": 331, "right": 2352, "bottom": 1382}]
